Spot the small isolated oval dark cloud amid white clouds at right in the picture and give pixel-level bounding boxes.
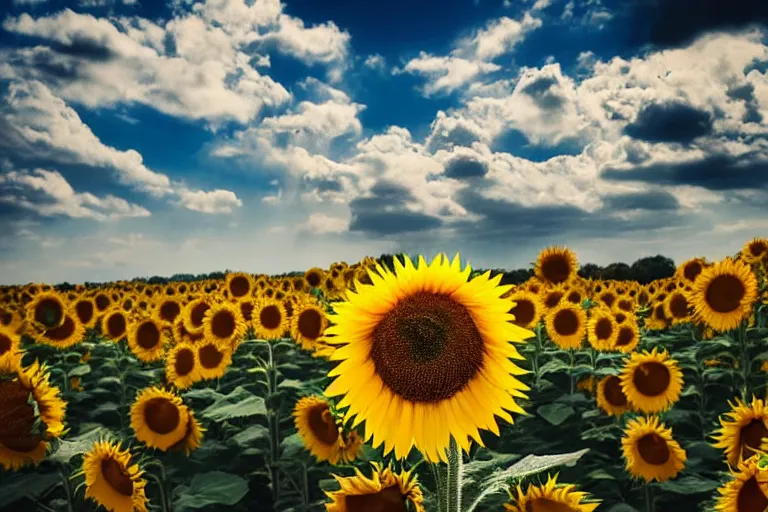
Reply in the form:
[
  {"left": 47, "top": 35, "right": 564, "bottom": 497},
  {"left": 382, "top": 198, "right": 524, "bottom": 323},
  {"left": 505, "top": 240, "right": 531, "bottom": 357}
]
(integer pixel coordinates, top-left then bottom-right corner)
[{"left": 624, "top": 102, "right": 713, "bottom": 144}]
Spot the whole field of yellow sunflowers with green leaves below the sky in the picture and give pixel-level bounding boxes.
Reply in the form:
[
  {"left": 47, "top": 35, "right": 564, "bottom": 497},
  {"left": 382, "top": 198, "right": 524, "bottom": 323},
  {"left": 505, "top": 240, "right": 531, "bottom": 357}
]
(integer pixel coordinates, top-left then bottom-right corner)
[{"left": 0, "top": 238, "right": 768, "bottom": 512}]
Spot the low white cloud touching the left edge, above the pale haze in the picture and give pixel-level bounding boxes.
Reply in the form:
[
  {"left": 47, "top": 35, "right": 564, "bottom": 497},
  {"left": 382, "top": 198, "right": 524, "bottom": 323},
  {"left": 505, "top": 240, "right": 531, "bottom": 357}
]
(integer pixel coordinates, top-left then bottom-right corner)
[{"left": 0, "top": 169, "right": 150, "bottom": 221}]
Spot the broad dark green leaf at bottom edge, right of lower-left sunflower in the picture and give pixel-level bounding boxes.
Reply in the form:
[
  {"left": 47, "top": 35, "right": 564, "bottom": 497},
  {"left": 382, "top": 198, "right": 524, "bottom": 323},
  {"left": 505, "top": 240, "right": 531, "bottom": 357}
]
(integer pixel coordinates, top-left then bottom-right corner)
[{"left": 173, "top": 471, "right": 248, "bottom": 510}]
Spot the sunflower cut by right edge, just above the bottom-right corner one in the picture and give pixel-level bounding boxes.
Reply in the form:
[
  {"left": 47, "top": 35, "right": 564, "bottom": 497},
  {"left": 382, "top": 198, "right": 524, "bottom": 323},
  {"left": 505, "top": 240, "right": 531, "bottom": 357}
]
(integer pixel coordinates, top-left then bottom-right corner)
[{"left": 713, "top": 396, "right": 768, "bottom": 467}]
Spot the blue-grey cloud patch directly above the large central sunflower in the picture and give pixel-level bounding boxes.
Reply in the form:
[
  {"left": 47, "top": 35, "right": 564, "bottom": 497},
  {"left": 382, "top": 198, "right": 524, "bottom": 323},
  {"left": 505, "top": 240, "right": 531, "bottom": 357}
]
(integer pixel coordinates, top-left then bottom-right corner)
[{"left": 349, "top": 181, "right": 442, "bottom": 236}]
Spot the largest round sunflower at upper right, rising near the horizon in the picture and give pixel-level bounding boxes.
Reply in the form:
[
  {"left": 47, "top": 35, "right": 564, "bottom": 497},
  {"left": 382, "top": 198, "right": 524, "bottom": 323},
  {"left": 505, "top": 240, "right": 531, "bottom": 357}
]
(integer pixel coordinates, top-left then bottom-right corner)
[{"left": 690, "top": 258, "right": 757, "bottom": 331}]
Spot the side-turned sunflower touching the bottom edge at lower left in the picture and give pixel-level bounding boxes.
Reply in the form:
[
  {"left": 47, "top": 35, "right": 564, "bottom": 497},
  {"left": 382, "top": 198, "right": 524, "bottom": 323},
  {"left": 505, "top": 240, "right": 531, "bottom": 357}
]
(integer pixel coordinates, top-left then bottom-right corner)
[{"left": 82, "top": 441, "right": 147, "bottom": 512}]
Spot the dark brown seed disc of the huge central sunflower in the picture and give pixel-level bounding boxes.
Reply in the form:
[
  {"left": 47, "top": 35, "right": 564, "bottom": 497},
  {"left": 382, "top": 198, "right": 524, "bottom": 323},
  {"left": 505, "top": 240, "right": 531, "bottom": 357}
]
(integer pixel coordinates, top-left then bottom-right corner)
[{"left": 371, "top": 292, "right": 485, "bottom": 402}]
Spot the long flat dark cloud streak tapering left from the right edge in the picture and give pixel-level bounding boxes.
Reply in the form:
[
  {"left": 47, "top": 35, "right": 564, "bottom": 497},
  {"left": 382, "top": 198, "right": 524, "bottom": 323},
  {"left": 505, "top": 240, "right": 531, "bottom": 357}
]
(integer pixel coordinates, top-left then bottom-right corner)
[{"left": 601, "top": 154, "right": 768, "bottom": 191}]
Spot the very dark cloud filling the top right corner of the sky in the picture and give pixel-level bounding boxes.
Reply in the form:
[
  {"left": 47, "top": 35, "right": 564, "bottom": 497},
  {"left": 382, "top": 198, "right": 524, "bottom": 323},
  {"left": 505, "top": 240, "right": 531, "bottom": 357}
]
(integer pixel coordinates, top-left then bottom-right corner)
[{"left": 624, "top": 0, "right": 768, "bottom": 48}]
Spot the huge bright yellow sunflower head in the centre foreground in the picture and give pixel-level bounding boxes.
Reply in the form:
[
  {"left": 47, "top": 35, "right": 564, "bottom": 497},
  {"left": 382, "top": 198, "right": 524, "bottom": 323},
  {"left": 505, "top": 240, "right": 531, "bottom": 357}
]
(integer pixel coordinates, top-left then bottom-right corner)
[{"left": 323, "top": 254, "right": 533, "bottom": 461}]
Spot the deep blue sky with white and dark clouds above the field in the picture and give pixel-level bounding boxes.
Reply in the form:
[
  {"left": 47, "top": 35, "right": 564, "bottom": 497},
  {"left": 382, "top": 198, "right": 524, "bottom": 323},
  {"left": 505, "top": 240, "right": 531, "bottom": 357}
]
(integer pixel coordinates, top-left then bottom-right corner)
[{"left": 0, "top": 0, "right": 768, "bottom": 283}]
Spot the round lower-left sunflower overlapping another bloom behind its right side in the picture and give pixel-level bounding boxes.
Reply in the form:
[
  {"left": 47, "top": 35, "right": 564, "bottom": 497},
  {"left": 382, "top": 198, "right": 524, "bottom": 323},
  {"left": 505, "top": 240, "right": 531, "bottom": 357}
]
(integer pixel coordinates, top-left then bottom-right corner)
[{"left": 131, "top": 387, "right": 189, "bottom": 451}]
